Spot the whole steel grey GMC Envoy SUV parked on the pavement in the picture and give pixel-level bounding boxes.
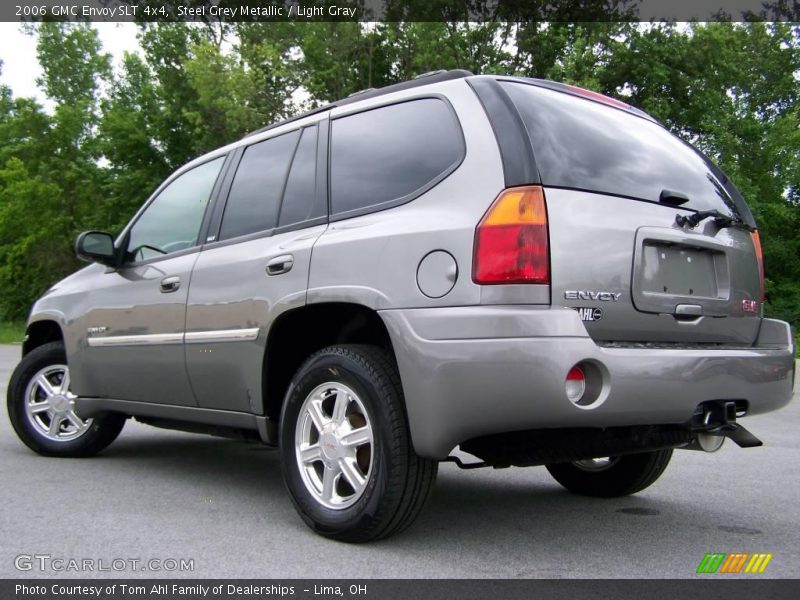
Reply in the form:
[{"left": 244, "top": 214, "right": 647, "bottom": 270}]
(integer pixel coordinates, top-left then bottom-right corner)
[{"left": 8, "top": 71, "right": 795, "bottom": 541}]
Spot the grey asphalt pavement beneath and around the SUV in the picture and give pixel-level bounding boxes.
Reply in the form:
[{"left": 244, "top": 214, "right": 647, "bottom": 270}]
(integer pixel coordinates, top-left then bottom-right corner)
[{"left": 0, "top": 346, "right": 800, "bottom": 578}]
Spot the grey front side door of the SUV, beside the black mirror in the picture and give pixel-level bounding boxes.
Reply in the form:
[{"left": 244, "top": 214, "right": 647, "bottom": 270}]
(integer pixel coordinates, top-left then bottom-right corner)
[{"left": 76, "top": 157, "right": 224, "bottom": 406}]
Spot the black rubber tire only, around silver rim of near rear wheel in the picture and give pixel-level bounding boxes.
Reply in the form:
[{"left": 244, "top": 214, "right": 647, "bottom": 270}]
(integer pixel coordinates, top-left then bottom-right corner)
[{"left": 280, "top": 345, "right": 438, "bottom": 542}]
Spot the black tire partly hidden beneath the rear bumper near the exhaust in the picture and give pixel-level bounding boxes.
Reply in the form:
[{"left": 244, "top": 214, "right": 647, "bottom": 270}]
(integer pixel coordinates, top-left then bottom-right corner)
[{"left": 547, "top": 448, "right": 672, "bottom": 498}]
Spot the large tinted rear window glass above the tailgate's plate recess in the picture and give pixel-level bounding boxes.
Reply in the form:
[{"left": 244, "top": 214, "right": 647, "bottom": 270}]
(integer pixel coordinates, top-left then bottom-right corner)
[{"left": 501, "top": 82, "right": 752, "bottom": 220}]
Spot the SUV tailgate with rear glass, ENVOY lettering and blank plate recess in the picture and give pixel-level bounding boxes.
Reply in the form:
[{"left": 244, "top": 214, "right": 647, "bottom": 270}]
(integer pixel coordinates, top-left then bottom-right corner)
[{"left": 501, "top": 81, "right": 762, "bottom": 344}]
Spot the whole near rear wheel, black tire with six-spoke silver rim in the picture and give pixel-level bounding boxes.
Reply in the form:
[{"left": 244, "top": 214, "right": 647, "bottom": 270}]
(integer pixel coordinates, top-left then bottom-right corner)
[{"left": 280, "top": 345, "right": 437, "bottom": 542}]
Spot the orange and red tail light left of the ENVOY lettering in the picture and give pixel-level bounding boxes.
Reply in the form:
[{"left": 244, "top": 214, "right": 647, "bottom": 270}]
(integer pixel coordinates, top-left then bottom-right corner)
[{"left": 472, "top": 186, "right": 550, "bottom": 284}]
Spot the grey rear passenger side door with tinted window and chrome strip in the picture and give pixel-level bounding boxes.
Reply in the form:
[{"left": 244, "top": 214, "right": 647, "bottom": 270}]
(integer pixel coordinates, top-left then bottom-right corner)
[{"left": 185, "top": 120, "right": 327, "bottom": 413}]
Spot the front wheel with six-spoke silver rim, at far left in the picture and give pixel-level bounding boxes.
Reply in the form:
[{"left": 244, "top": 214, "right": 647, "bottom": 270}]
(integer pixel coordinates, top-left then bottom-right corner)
[{"left": 8, "top": 342, "right": 125, "bottom": 457}]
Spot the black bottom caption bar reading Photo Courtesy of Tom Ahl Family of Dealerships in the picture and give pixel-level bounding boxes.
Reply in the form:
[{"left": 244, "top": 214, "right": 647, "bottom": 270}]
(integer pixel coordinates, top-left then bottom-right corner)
[{"left": 0, "top": 580, "right": 800, "bottom": 600}]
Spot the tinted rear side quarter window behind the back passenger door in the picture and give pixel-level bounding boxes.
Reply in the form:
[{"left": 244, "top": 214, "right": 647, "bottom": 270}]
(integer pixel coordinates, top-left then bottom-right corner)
[{"left": 330, "top": 98, "right": 465, "bottom": 219}]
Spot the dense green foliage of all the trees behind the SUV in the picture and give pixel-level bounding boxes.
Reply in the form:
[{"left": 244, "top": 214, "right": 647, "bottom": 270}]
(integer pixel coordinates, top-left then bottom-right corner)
[{"left": 0, "top": 21, "right": 800, "bottom": 323}]
